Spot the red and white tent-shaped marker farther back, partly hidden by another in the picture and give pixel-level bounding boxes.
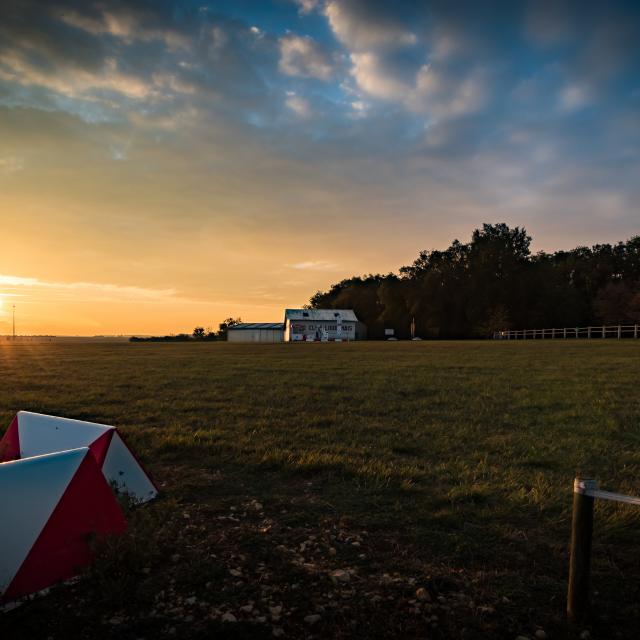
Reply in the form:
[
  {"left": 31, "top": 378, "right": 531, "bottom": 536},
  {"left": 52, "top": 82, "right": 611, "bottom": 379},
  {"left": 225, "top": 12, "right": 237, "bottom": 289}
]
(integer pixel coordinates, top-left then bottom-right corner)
[{"left": 0, "top": 411, "right": 158, "bottom": 508}]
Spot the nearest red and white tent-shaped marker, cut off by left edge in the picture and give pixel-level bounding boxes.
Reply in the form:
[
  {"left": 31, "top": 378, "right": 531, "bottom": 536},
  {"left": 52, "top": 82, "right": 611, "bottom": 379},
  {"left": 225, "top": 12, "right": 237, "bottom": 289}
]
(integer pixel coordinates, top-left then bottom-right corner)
[{"left": 0, "top": 447, "right": 127, "bottom": 602}]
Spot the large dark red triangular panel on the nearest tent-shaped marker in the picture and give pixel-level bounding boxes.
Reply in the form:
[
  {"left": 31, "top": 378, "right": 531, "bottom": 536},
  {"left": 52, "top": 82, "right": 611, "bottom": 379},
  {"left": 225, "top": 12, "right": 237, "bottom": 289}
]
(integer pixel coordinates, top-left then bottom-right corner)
[{"left": 3, "top": 455, "right": 127, "bottom": 600}]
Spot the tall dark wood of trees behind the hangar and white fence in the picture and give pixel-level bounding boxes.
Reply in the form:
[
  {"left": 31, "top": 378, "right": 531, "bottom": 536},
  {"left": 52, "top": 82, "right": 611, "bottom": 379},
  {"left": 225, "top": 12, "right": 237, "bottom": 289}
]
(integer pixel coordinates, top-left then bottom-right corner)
[{"left": 307, "top": 223, "right": 640, "bottom": 338}]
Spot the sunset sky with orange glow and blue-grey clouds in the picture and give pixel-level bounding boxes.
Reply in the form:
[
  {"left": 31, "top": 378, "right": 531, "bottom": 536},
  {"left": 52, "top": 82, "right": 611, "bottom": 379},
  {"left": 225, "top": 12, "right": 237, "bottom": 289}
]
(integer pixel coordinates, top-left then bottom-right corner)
[{"left": 0, "top": 0, "right": 640, "bottom": 335}]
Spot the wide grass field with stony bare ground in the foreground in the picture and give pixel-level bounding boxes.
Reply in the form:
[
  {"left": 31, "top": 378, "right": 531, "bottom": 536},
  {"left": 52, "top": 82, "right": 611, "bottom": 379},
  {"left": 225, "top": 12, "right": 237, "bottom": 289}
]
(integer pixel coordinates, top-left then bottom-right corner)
[{"left": 0, "top": 340, "right": 640, "bottom": 639}]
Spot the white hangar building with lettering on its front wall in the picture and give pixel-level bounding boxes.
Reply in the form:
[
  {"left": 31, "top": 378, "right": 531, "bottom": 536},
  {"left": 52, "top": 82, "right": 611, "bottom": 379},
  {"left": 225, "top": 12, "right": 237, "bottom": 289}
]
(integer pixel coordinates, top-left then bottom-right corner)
[{"left": 284, "top": 309, "right": 366, "bottom": 342}]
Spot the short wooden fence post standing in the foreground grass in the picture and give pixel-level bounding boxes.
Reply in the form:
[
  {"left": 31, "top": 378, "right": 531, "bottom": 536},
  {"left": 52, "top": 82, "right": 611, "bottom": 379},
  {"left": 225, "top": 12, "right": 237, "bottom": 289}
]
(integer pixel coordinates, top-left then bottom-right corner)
[{"left": 567, "top": 478, "right": 598, "bottom": 623}]
